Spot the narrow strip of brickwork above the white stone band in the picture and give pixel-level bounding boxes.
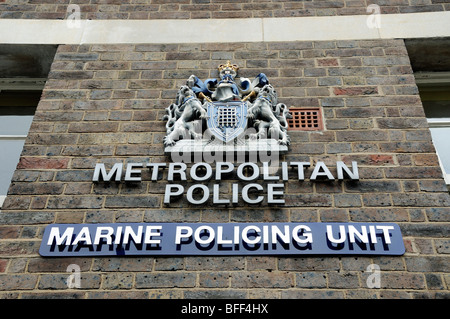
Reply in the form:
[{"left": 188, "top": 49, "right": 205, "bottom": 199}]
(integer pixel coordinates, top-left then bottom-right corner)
[{"left": 0, "top": 0, "right": 450, "bottom": 19}]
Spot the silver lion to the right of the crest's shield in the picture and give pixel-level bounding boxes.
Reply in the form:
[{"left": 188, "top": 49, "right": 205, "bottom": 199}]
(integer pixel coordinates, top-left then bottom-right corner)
[{"left": 247, "top": 84, "right": 292, "bottom": 145}]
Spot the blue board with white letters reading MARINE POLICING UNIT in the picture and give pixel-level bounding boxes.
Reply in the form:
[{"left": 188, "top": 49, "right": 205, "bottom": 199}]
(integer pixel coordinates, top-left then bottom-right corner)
[{"left": 39, "top": 223, "right": 405, "bottom": 257}]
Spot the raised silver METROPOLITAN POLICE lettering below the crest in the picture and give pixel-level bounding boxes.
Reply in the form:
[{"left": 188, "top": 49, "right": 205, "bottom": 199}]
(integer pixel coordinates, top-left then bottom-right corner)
[{"left": 92, "top": 161, "right": 359, "bottom": 205}]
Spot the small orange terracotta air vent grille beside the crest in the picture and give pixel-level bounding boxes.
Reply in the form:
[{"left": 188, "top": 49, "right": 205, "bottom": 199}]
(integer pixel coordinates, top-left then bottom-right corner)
[{"left": 288, "top": 107, "right": 323, "bottom": 131}]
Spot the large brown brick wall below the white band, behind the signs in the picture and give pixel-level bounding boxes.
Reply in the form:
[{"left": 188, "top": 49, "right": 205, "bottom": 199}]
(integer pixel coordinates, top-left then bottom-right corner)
[{"left": 0, "top": 39, "right": 450, "bottom": 298}]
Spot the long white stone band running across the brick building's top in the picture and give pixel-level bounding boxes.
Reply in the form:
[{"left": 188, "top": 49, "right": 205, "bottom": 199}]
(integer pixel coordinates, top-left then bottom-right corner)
[{"left": 0, "top": 11, "right": 450, "bottom": 44}]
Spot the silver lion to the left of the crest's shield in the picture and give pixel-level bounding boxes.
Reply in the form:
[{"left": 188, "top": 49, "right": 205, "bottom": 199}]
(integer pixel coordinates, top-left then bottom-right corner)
[{"left": 163, "top": 85, "right": 207, "bottom": 147}]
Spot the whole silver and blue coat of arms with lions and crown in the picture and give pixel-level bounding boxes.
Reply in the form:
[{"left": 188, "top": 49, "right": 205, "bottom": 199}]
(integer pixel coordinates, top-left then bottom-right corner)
[{"left": 163, "top": 61, "right": 291, "bottom": 154}]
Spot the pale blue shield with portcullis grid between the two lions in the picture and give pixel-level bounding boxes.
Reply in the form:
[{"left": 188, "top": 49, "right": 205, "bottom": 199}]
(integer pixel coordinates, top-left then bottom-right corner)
[{"left": 207, "top": 101, "right": 247, "bottom": 143}]
